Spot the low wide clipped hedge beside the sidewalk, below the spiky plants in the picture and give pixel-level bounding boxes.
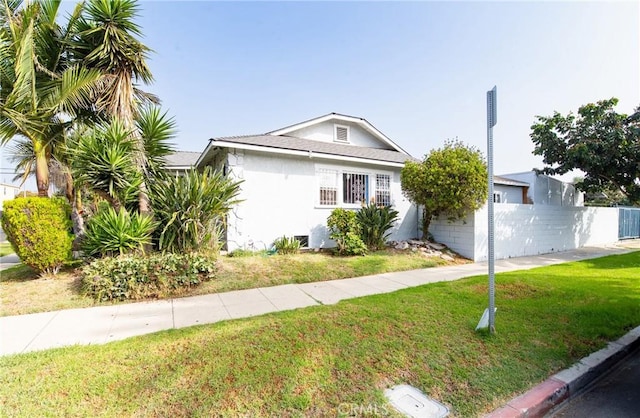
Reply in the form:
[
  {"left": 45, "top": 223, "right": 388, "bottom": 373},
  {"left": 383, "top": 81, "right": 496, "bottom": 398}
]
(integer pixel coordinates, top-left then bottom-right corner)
[{"left": 80, "top": 253, "right": 216, "bottom": 302}]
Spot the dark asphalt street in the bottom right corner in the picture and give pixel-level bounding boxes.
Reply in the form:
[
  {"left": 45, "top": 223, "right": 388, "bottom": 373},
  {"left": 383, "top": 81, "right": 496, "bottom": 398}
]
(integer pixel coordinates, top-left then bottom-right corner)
[{"left": 548, "top": 347, "right": 640, "bottom": 418}]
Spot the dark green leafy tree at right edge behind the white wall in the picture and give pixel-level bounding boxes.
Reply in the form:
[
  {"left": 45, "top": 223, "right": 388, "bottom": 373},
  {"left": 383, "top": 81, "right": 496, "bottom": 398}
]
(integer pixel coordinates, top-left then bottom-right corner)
[{"left": 531, "top": 98, "right": 640, "bottom": 204}]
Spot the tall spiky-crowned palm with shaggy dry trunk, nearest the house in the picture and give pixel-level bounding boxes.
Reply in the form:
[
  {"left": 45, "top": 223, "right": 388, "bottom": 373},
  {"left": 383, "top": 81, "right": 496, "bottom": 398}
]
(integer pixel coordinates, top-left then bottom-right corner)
[{"left": 71, "top": 0, "right": 158, "bottom": 213}]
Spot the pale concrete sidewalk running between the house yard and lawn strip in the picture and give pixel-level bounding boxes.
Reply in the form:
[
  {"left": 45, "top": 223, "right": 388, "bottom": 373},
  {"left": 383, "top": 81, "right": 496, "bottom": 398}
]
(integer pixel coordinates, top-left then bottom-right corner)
[{"left": 0, "top": 246, "right": 630, "bottom": 355}]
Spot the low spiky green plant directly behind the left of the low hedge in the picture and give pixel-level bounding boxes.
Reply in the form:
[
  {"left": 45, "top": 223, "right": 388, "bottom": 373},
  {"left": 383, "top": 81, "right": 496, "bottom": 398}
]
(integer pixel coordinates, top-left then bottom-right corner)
[{"left": 82, "top": 207, "right": 158, "bottom": 257}]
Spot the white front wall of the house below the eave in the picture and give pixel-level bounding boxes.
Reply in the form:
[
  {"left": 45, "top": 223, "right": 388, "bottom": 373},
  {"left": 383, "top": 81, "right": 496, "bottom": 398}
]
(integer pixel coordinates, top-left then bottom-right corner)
[{"left": 227, "top": 150, "right": 418, "bottom": 251}]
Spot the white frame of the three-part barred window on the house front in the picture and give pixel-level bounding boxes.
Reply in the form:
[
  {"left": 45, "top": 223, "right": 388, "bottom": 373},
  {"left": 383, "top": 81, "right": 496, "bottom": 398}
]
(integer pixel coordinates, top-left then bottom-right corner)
[{"left": 314, "top": 164, "right": 394, "bottom": 209}]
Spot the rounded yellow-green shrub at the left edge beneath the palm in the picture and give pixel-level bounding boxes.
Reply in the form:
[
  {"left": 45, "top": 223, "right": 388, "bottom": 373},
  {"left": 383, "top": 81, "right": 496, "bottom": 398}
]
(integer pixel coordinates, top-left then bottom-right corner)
[{"left": 2, "top": 197, "right": 73, "bottom": 274}]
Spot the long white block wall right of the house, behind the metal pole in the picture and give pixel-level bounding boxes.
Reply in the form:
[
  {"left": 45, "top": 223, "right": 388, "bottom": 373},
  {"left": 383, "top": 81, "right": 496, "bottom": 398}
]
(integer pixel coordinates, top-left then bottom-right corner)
[{"left": 429, "top": 204, "right": 618, "bottom": 261}]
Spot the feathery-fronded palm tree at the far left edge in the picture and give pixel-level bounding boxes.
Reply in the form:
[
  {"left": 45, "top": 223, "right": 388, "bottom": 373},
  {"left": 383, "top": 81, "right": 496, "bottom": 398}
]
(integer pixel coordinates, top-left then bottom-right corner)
[{"left": 0, "top": 0, "right": 100, "bottom": 197}]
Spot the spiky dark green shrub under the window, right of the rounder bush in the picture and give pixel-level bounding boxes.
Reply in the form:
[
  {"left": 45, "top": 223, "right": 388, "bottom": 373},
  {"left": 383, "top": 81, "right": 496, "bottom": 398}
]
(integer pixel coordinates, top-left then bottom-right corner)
[{"left": 356, "top": 203, "right": 398, "bottom": 251}]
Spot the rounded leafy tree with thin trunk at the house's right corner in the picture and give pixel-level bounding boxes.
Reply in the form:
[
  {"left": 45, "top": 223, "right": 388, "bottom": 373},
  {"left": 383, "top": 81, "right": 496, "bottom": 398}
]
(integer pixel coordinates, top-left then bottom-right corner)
[{"left": 400, "top": 140, "right": 488, "bottom": 239}]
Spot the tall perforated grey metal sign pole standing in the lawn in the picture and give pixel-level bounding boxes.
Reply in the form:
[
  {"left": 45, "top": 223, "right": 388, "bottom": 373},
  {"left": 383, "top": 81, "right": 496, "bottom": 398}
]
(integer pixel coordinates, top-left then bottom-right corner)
[{"left": 487, "top": 86, "right": 497, "bottom": 334}]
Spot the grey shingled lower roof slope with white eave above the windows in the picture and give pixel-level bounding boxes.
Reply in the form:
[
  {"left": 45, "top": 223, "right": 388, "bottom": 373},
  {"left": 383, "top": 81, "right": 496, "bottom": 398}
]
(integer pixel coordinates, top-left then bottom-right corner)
[{"left": 198, "top": 134, "right": 417, "bottom": 167}]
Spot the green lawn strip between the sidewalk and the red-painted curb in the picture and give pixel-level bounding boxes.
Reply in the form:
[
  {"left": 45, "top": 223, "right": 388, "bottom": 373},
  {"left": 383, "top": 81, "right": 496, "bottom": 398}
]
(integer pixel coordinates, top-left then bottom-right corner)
[{"left": 0, "top": 252, "right": 640, "bottom": 417}]
